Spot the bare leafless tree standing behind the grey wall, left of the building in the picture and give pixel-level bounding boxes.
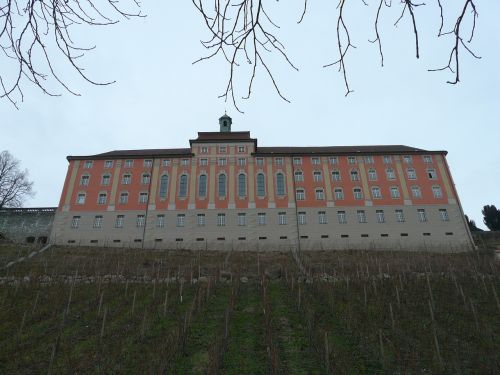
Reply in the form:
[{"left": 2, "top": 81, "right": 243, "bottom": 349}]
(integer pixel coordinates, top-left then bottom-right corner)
[{"left": 0, "top": 151, "right": 34, "bottom": 209}]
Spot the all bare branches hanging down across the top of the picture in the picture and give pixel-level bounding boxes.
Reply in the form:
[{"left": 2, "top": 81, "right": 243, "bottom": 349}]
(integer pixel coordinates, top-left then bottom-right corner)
[{"left": 0, "top": 0, "right": 479, "bottom": 110}]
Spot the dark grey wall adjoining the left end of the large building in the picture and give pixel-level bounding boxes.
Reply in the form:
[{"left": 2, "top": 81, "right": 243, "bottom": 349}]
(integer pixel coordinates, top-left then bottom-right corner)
[{"left": 0, "top": 207, "right": 56, "bottom": 243}]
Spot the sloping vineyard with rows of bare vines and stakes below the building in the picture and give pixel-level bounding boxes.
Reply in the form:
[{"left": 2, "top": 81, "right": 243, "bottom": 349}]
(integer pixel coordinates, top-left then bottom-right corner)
[{"left": 0, "top": 247, "right": 500, "bottom": 374}]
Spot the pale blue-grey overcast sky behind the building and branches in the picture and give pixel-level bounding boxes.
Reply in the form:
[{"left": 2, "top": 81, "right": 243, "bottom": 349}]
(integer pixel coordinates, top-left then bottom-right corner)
[{"left": 0, "top": 0, "right": 500, "bottom": 227}]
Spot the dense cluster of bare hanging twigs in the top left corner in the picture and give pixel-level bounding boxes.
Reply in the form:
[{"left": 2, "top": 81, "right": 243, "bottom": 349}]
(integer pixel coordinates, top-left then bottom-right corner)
[{"left": 0, "top": 0, "right": 141, "bottom": 107}]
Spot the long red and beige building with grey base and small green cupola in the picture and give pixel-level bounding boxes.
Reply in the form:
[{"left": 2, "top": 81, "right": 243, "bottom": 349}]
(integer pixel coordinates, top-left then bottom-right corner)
[{"left": 51, "top": 115, "right": 474, "bottom": 251}]
